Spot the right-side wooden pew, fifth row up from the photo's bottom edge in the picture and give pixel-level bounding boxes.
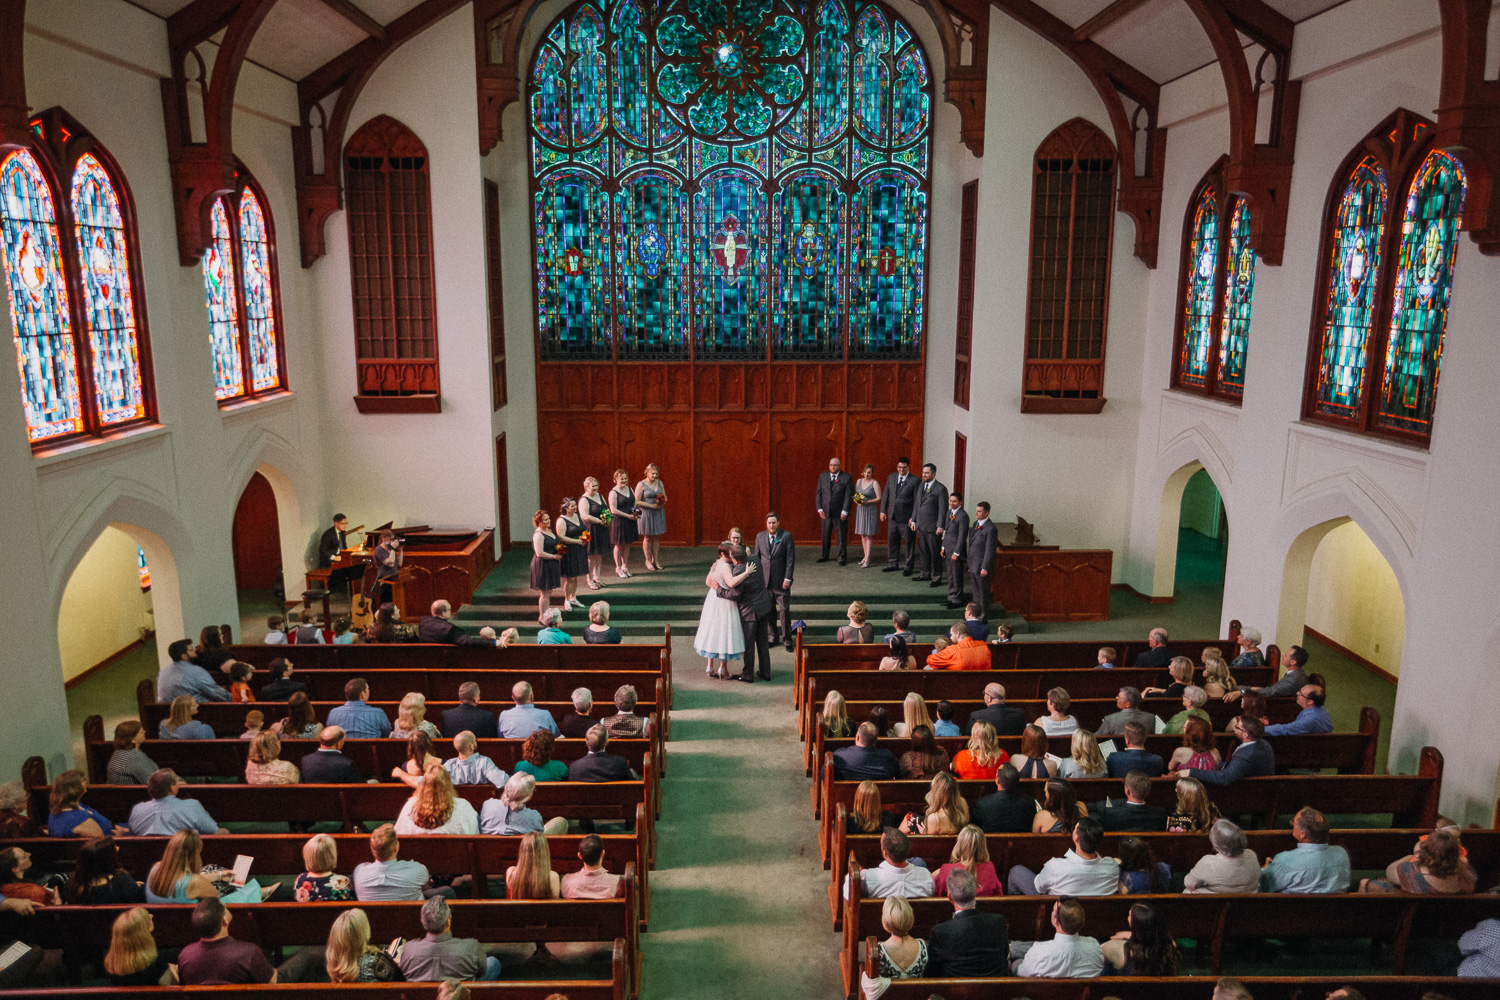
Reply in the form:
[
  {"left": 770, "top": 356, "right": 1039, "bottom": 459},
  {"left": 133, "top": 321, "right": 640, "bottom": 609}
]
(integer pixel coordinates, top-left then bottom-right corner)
[{"left": 810, "top": 705, "right": 1380, "bottom": 816}]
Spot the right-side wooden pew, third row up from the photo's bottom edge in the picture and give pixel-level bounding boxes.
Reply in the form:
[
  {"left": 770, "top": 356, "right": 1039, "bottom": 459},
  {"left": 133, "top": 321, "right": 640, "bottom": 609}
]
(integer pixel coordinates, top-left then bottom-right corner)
[{"left": 828, "top": 807, "right": 1500, "bottom": 930}]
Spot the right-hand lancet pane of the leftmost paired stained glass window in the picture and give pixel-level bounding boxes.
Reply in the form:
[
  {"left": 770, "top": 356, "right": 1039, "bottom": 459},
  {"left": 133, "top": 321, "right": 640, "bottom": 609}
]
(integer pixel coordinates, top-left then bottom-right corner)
[{"left": 72, "top": 153, "right": 146, "bottom": 424}]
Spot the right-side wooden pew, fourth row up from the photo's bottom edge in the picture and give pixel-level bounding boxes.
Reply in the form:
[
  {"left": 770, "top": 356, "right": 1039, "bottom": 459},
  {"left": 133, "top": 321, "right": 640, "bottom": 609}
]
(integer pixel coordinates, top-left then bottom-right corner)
[{"left": 818, "top": 747, "right": 1443, "bottom": 868}]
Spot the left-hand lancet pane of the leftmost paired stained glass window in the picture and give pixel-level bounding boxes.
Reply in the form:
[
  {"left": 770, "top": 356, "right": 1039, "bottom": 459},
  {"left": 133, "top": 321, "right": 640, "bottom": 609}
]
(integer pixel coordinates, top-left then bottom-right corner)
[{"left": 0, "top": 150, "right": 84, "bottom": 442}]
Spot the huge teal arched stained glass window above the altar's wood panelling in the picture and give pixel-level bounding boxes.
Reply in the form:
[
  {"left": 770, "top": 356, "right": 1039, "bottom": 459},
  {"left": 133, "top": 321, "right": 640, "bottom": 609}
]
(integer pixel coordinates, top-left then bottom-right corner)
[{"left": 528, "top": 0, "right": 932, "bottom": 360}]
